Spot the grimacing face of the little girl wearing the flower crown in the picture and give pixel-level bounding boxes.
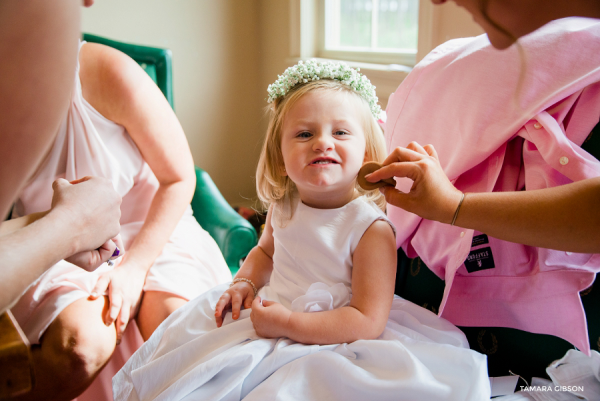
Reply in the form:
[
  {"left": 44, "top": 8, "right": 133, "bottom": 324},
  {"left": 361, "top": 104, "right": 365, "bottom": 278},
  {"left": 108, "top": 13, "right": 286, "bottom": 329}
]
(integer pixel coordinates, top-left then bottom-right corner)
[{"left": 281, "top": 90, "right": 366, "bottom": 208}]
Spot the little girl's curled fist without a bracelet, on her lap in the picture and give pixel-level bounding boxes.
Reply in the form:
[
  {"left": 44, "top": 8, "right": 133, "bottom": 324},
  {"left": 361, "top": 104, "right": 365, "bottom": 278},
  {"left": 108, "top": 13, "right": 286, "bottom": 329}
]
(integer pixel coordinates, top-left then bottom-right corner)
[{"left": 250, "top": 297, "right": 292, "bottom": 338}]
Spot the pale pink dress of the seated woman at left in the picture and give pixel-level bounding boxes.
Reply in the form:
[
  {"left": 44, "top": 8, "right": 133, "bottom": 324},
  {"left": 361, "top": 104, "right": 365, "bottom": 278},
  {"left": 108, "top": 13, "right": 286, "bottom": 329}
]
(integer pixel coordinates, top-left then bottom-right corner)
[{"left": 12, "top": 42, "right": 231, "bottom": 400}]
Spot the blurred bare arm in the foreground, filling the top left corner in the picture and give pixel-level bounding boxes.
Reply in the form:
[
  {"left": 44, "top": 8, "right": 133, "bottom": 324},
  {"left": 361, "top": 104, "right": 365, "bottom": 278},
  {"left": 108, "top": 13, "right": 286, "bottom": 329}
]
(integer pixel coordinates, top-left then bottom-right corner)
[{"left": 0, "top": 0, "right": 81, "bottom": 219}]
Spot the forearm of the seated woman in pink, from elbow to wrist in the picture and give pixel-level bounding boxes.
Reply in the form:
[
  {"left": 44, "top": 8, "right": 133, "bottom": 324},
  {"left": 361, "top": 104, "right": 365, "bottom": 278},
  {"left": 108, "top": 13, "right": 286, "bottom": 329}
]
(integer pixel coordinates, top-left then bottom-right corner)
[{"left": 123, "top": 180, "right": 195, "bottom": 272}]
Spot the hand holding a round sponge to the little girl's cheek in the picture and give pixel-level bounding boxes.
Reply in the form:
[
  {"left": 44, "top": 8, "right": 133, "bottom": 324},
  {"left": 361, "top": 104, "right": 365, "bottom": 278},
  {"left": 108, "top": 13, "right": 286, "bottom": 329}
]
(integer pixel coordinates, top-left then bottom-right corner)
[{"left": 365, "top": 142, "right": 462, "bottom": 224}]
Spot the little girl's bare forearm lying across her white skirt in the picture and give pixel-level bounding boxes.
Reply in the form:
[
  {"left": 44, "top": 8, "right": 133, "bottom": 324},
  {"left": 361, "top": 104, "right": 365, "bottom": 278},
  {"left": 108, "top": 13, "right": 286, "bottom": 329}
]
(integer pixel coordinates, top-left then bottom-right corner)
[{"left": 286, "top": 306, "right": 387, "bottom": 345}]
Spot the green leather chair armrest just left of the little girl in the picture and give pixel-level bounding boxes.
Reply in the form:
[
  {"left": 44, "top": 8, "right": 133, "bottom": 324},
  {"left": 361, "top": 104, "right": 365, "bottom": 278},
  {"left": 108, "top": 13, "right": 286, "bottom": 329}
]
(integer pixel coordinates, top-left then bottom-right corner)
[{"left": 192, "top": 167, "right": 257, "bottom": 274}]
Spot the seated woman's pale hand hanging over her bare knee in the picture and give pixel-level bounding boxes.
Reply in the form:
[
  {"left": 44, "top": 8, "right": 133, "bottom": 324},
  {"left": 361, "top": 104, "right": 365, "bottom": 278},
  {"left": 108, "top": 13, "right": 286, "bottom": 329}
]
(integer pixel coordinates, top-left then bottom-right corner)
[{"left": 90, "top": 261, "right": 147, "bottom": 344}]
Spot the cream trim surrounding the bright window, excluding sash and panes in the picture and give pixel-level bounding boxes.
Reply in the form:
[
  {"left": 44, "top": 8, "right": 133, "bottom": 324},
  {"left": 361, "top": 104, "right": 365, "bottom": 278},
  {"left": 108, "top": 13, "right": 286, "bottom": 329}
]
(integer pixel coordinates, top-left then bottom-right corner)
[{"left": 286, "top": 0, "right": 437, "bottom": 108}]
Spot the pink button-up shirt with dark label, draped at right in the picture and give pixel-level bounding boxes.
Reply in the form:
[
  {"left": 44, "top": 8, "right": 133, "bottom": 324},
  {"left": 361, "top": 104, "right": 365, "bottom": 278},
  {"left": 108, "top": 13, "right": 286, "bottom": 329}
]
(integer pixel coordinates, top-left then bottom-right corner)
[{"left": 385, "top": 18, "right": 600, "bottom": 353}]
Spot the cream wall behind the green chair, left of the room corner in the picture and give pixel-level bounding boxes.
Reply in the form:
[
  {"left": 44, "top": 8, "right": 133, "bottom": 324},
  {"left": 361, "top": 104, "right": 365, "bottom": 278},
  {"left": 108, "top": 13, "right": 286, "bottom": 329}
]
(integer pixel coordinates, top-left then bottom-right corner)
[{"left": 82, "top": 0, "right": 264, "bottom": 205}]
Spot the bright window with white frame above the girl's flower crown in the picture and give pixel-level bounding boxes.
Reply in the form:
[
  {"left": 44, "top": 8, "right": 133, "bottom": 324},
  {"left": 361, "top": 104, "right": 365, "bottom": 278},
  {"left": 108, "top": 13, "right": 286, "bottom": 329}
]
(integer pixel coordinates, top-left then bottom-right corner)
[{"left": 319, "top": 0, "right": 419, "bottom": 65}]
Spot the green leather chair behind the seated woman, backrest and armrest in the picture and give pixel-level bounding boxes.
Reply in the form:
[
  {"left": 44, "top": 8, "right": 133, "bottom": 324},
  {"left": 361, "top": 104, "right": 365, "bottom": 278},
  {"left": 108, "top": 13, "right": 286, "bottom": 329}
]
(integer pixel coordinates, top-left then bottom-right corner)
[{"left": 83, "top": 33, "right": 257, "bottom": 274}]
